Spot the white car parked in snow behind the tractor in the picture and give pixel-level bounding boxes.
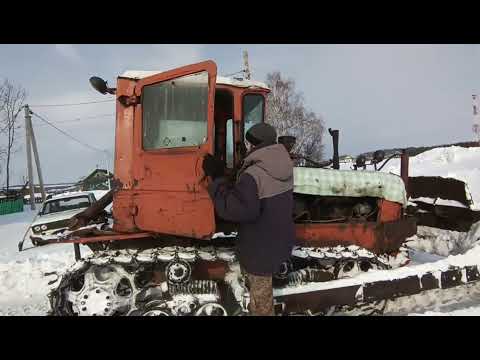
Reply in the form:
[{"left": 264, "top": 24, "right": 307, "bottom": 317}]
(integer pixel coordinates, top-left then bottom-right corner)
[{"left": 30, "top": 192, "right": 97, "bottom": 245}]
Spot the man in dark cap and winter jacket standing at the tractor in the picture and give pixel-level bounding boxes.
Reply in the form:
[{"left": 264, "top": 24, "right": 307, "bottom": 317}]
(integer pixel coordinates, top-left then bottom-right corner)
[{"left": 203, "top": 123, "right": 295, "bottom": 316}]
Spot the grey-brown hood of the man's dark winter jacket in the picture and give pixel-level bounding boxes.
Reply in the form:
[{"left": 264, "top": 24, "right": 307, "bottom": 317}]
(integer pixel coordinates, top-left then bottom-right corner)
[{"left": 243, "top": 144, "right": 293, "bottom": 181}]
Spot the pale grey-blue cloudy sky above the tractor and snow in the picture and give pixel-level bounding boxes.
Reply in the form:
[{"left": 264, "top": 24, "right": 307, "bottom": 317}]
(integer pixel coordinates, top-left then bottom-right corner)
[{"left": 0, "top": 44, "right": 480, "bottom": 185}]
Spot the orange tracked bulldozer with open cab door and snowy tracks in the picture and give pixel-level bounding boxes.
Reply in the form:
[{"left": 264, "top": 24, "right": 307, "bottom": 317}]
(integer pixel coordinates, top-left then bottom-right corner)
[{"left": 27, "top": 61, "right": 478, "bottom": 316}]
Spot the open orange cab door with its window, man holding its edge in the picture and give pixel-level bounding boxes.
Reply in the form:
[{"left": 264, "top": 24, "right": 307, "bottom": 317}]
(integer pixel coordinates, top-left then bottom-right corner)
[{"left": 129, "top": 61, "right": 217, "bottom": 239}]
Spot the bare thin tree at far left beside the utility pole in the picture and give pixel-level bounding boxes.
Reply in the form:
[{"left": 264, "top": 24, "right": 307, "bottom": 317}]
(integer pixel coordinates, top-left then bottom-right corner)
[{"left": 0, "top": 79, "right": 27, "bottom": 191}]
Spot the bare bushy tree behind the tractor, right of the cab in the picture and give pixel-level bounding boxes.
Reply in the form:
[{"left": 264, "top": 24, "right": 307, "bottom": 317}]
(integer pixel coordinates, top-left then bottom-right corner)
[{"left": 266, "top": 72, "right": 325, "bottom": 161}]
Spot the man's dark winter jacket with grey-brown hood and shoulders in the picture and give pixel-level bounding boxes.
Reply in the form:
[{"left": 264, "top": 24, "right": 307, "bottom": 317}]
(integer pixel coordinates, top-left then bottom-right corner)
[{"left": 208, "top": 144, "right": 295, "bottom": 275}]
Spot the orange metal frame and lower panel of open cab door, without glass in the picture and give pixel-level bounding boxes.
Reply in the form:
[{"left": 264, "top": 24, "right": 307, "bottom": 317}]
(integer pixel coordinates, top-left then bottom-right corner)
[{"left": 122, "top": 61, "right": 217, "bottom": 239}]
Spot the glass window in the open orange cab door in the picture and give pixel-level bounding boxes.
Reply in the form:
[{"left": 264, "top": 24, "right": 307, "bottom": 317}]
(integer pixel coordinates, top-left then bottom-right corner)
[{"left": 142, "top": 71, "right": 208, "bottom": 150}]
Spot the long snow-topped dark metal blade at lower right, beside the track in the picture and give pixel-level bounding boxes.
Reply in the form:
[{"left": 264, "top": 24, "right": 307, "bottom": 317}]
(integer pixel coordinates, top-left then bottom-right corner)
[{"left": 274, "top": 247, "right": 480, "bottom": 313}]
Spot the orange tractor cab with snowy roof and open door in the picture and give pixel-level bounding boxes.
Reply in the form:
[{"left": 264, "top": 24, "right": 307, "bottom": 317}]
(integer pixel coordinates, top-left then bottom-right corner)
[{"left": 113, "top": 61, "right": 269, "bottom": 239}]
